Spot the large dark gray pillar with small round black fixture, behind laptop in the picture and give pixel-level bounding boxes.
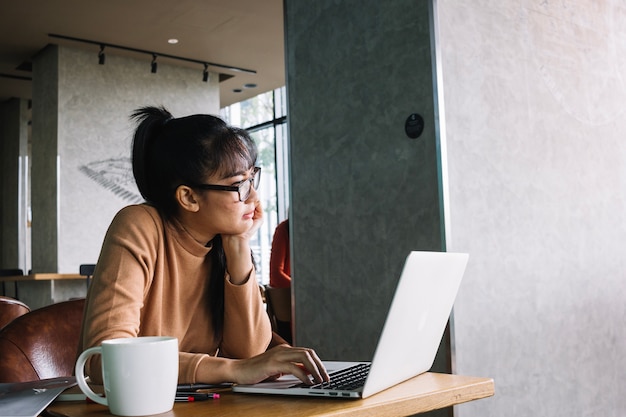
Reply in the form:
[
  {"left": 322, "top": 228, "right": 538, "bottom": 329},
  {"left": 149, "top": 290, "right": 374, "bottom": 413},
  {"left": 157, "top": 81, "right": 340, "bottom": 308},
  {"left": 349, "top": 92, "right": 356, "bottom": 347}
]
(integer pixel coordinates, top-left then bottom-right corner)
[{"left": 285, "top": 0, "right": 449, "bottom": 367}]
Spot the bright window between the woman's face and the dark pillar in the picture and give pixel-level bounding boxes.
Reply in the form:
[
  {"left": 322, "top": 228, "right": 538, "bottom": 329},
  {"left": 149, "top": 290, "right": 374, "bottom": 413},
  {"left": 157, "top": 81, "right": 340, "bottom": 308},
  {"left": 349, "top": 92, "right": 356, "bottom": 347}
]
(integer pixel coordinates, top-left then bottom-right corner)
[{"left": 221, "top": 87, "right": 289, "bottom": 285}]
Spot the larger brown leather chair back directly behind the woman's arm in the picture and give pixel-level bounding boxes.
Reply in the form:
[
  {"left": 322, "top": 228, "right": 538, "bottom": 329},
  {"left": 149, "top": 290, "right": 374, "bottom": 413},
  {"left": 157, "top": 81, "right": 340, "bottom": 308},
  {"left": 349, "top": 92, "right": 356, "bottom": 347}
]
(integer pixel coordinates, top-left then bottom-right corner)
[{"left": 0, "top": 298, "right": 85, "bottom": 382}]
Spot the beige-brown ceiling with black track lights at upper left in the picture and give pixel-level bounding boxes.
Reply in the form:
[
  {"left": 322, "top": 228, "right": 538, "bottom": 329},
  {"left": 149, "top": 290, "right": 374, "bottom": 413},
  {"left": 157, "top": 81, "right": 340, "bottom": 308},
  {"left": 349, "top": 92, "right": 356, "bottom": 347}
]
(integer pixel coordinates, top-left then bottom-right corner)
[{"left": 0, "top": 0, "right": 285, "bottom": 107}]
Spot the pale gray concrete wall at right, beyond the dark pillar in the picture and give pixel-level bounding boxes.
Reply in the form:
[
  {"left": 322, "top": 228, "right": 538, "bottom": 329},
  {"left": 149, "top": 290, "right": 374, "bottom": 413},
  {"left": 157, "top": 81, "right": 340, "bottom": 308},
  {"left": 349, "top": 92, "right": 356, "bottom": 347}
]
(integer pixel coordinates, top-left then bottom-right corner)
[{"left": 436, "top": 0, "right": 626, "bottom": 417}]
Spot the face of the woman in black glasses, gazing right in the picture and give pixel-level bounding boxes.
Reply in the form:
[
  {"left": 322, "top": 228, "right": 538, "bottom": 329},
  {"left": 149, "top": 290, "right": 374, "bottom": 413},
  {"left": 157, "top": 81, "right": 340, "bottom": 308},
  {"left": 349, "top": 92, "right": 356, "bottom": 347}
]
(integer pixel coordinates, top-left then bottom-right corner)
[{"left": 197, "top": 167, "right": 258, "bottom": 239}]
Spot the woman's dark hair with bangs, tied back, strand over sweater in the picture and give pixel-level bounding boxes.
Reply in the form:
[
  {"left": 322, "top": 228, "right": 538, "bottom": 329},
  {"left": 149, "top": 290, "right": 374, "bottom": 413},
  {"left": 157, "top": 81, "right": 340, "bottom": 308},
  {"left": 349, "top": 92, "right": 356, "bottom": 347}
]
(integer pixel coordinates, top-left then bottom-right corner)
[{"left": 131, "top": 107, "right": 258, "bottom": 338}]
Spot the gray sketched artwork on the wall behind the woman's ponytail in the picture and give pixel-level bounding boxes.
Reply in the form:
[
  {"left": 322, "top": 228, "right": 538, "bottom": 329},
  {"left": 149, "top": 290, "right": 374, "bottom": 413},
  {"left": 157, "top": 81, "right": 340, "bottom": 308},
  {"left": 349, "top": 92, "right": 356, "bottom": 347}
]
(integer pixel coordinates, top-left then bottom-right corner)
[{"left": 79, "top": 158, "right": 144, "bottom": 203}]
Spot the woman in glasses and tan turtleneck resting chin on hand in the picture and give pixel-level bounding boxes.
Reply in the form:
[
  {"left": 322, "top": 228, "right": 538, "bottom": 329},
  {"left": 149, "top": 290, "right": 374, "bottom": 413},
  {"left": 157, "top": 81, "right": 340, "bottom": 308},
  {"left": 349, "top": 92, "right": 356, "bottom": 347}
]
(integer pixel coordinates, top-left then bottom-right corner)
[{"left": 81, "top": 107, "right": 328, "bottom": 383}]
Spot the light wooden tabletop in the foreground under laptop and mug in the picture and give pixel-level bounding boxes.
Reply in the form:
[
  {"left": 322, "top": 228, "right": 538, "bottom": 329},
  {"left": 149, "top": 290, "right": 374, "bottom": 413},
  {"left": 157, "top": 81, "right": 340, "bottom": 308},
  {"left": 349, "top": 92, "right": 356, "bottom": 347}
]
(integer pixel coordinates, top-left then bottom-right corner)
[{"left": 48, "top": 372, "right": 494, "bottom": 417}]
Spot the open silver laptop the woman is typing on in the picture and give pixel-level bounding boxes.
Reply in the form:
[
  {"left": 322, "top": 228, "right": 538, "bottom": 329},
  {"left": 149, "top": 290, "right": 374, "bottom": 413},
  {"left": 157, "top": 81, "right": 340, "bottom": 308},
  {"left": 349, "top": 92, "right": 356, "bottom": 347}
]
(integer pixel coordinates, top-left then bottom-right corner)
[{"left": 233, "top": 251, "right": 469, "bottom": 398}]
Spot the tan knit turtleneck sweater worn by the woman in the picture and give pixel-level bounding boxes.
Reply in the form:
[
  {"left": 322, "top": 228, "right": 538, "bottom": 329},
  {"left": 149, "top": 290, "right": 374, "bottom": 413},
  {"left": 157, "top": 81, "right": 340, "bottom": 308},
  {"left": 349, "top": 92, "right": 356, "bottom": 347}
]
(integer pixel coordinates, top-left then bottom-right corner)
[{"left": 80, "top": 204, "right": 272, "bottom": 383}]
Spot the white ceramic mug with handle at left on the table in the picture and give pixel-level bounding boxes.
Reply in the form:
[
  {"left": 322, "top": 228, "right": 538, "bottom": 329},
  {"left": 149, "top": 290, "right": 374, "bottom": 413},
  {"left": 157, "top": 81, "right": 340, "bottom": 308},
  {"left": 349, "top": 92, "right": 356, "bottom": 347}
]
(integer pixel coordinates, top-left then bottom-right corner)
[{"left": 76, "top": 336, "right": 178, "bottom": 416}]
